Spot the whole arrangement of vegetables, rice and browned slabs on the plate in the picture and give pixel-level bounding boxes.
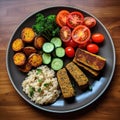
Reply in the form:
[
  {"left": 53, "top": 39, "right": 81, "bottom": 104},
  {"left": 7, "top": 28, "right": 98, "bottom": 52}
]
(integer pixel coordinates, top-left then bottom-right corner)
[{"left": 12, "top": 10, "right": 106, "bottom": 105}]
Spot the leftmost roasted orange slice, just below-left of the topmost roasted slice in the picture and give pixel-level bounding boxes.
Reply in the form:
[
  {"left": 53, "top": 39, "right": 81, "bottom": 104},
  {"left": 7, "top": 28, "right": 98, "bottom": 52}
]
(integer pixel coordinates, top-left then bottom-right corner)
[{"left": 12, "top": 38, "right": 24, "bottom": 52}]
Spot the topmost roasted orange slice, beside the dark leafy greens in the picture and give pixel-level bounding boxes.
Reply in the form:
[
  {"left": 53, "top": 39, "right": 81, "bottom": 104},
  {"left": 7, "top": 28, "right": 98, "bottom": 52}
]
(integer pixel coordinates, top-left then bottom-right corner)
[{"left": 21, "top": 27, "right": 35, "bottom": 43}]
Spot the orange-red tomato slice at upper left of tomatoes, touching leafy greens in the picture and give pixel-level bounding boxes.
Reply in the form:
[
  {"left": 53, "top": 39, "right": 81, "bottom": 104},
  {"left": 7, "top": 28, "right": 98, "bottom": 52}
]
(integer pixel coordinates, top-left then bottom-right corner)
[{"left": 56, "top": 10, "right": 69, "bottom": 27}]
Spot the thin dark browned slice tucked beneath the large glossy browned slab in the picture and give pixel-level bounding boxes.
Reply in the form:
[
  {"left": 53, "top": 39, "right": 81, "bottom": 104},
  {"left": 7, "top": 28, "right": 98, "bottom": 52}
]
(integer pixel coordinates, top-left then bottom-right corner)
[{"left": 73, "top": 58, "right": 99, "bottom": 77}]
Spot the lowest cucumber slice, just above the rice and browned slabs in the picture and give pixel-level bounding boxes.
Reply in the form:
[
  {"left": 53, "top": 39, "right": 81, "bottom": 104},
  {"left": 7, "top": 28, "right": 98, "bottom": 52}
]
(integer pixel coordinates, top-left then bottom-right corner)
[{"left": 51, "top": 58, "right": 63, "bottom": 71}]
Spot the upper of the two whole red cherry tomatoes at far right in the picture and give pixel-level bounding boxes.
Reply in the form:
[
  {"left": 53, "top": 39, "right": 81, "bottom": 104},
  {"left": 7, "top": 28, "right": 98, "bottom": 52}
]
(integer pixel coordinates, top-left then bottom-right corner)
[{"left": 92, "top": 33, "right": 105, "bottom": 43}]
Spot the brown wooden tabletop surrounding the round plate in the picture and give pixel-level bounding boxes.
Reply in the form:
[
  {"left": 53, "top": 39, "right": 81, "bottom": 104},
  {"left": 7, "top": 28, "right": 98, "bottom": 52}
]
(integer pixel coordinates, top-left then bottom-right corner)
[{"left": 0, "top": 0, "right": 120, "bottom": 120}]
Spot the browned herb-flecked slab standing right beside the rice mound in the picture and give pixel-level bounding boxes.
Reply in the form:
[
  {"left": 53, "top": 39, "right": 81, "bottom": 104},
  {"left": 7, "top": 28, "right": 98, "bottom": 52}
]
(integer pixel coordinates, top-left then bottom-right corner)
[{"left": 57, "top": 68, "right": 75, "bottom": 98}]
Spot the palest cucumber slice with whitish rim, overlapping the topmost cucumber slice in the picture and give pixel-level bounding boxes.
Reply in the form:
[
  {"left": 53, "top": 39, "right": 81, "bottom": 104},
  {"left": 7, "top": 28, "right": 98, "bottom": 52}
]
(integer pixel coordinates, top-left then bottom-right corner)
[{"left": 42, "top": 42, "right": 54, "bottom": 53}]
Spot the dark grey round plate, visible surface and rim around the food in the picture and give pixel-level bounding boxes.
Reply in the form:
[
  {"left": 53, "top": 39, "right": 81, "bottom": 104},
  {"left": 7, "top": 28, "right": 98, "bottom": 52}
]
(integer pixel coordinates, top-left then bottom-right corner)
[{"left": 6, "top": 6, "right": 116, "bottom": 113}]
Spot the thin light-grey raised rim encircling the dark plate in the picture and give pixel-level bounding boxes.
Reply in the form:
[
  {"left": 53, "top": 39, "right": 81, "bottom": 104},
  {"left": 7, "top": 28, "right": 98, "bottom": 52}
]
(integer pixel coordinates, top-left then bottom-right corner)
[{"left": 6, "top": 5, "right": 116, "bottom": 113}]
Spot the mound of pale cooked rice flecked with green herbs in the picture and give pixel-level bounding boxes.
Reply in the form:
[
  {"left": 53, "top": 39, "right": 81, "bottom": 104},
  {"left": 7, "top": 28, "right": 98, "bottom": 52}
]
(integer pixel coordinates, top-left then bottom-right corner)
[{"left": 22, "top": 65, "right": 60, "bottom": 105}]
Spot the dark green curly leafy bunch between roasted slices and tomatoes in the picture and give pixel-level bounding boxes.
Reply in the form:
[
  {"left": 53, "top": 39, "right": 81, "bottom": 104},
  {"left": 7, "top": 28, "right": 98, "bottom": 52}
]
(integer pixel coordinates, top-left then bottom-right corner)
[{"left": 32, "top": 13, "right": 60, "bottom": 41}]
